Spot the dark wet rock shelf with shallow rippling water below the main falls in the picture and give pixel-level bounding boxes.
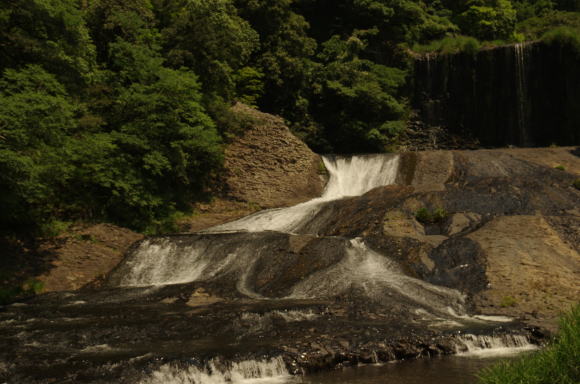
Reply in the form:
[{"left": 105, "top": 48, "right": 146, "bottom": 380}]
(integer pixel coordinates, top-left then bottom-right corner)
[{"left": 0, "top": 284, "right": 540, "bottom": 383}]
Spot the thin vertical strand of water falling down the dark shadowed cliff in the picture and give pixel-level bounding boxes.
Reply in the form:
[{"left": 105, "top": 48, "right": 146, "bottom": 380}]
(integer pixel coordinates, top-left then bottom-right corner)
[{"left": 514, "top": 43, "right": 529, "bottom": 145}]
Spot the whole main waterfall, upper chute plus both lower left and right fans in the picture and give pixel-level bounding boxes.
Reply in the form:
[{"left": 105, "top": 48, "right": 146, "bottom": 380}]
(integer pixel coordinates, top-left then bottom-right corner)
[{"left": 113, "top": 155, "right": 465, "bottom": 316}]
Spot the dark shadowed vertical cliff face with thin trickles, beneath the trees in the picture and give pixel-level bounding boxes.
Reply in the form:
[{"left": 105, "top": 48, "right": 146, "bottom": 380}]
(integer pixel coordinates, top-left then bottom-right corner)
[{"left": 414, "top": 43, "right": 580, "bottom": 147}]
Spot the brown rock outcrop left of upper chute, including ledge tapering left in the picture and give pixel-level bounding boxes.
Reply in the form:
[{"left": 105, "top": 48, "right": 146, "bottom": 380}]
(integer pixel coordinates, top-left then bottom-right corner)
[{"left": 180, "top": 103, "right": 326, "bottom": 232}]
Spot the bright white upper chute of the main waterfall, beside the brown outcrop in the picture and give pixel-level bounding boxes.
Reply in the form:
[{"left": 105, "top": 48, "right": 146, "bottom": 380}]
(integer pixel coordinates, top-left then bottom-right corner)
[{"left": 203, "top": 155, "right": 399, "bottom": 233}]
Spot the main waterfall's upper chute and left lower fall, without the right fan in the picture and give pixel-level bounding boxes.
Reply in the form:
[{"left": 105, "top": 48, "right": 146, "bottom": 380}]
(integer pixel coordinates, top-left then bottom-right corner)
[{"left": 112, "top": 155, "right": 399, "bottom": 286}]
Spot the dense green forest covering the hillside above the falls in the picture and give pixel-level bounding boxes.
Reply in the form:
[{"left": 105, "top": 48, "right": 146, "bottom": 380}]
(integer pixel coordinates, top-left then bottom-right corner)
[{"left": 0, "top": 0, "right": 580, "bottom": 236}]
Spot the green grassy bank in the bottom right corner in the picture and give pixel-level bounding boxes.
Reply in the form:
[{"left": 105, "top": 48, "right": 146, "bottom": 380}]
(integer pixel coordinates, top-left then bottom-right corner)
[{"left": 480, "top": 305, "right": 580, "bottom": 384}]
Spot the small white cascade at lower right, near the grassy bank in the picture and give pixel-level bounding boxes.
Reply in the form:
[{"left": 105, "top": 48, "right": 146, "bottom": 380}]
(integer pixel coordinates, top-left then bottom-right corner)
[{"left": 455, "top": 334, "right": 538, "bottom": 357}]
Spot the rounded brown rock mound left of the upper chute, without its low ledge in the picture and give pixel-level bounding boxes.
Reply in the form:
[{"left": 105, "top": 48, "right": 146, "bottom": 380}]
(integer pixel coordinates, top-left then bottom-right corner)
[{"left": 225, "top": 104, "right": 325, "bottom": 208}]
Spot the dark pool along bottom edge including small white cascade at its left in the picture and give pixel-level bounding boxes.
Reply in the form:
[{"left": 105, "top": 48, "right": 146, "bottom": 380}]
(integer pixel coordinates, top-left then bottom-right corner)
[{"left": 140, "top": 349, "right": 529, "bottom": 384}]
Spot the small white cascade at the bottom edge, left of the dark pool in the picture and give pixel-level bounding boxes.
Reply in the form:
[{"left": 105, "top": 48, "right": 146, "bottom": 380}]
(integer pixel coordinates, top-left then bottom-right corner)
[{"left": 140, "top": 357, "right": 290, "bottom": 384}]
